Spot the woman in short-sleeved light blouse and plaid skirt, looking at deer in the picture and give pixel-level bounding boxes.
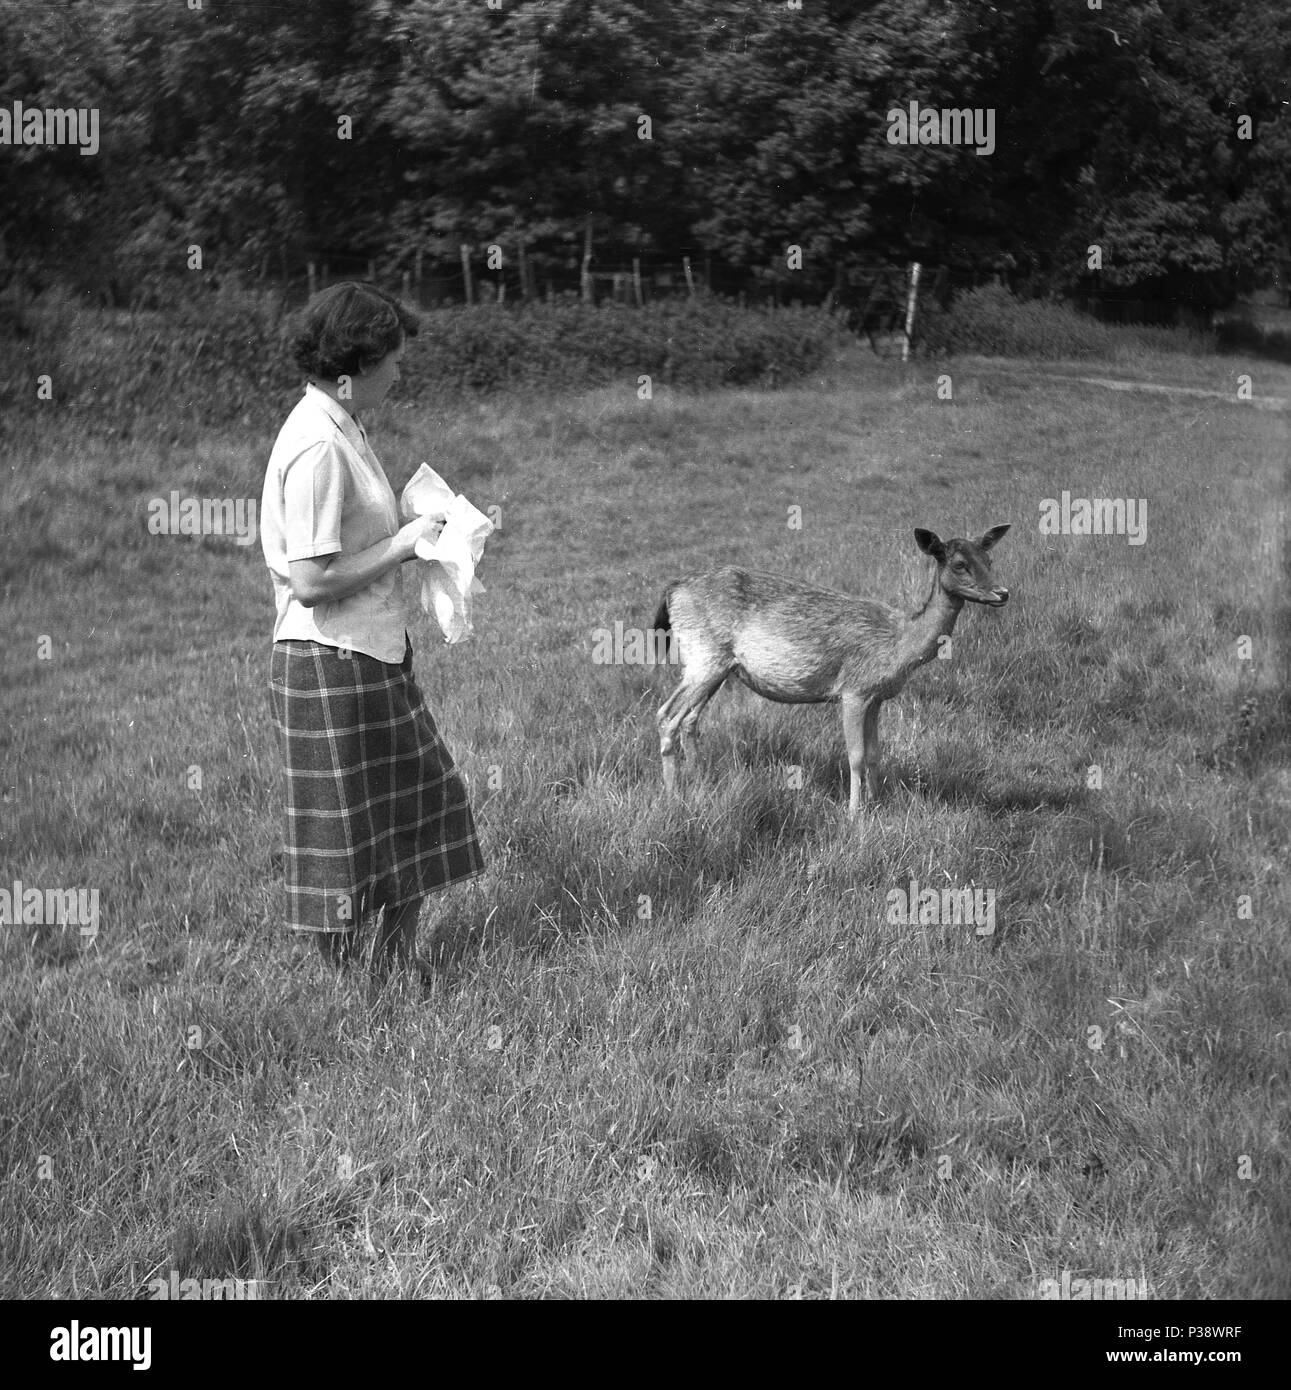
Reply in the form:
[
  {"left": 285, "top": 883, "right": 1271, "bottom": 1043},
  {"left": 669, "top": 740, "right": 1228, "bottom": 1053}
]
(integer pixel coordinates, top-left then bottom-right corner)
[{"left": 260, "top": 282, "right": 484, "bottom": 979}]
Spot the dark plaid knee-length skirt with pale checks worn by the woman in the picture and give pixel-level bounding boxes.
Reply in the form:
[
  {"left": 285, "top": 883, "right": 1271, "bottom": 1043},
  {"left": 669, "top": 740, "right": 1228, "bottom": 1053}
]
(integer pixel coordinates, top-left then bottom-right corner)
[{"left": 270, "top": 641, "right": 484, "bottom": 931}]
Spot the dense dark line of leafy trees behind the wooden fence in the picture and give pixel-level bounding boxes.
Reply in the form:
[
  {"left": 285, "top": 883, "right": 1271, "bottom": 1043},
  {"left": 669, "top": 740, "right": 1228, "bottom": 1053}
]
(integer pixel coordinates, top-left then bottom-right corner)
[{"left": 0, "top": 0, "right": 1291, "bottom": 304}]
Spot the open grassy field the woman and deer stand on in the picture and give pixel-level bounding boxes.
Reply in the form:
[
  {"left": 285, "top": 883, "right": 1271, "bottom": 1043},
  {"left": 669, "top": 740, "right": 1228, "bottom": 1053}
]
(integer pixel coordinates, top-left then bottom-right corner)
[{"left": 0, "top": 339, "right": 1291, "bottom": 1298}]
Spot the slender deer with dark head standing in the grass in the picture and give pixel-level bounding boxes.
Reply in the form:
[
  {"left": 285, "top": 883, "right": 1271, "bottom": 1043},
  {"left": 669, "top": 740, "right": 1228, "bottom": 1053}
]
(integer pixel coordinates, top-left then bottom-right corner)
[{"left": 655, "top": 524, "right": 1009, "bottom": 819}]
